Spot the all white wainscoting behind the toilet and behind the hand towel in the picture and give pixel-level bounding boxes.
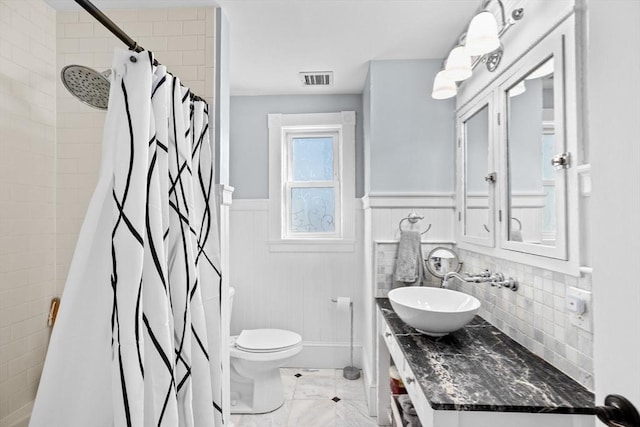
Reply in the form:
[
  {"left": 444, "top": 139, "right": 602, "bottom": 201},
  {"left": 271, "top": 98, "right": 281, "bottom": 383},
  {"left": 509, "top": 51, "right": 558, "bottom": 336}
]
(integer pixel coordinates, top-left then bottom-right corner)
[{"left": 228, "top": 193, "right": 455, "bottom": 411}]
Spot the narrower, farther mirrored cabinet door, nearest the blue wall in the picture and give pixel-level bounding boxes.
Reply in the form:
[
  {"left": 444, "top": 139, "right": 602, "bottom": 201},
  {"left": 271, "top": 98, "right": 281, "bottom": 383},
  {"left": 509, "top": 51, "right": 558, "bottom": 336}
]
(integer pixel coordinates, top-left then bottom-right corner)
[{"left": 457, "top": 95, "right": 497, "bottom": 246}]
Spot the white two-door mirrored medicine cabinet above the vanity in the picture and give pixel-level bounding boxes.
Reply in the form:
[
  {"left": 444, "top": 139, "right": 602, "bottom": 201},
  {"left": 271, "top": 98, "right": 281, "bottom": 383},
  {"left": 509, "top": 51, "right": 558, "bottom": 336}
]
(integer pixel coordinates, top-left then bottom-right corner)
[{"left": 456, "top": 16, "right": 577, "bottom": 262}]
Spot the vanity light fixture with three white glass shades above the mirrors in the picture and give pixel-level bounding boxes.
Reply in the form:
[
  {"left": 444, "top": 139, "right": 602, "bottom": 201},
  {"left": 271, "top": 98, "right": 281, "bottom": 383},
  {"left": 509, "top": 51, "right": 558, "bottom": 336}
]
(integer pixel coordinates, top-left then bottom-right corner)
[{"left": 431, "top": 0, "right": 524, "bottom": 99}]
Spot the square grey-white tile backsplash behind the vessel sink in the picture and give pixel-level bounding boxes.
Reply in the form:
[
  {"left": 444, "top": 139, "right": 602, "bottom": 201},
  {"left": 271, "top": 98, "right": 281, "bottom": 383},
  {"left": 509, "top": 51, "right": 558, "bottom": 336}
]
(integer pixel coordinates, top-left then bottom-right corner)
[{"left": 375, "top": 241, "right": 594, "bottom": 390}]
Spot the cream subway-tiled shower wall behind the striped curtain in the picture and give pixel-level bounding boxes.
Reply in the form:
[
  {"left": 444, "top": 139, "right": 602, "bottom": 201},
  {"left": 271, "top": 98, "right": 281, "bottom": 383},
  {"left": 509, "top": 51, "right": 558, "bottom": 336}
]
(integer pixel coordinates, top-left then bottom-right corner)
[{"left": 0, "top": 5, "right": 215, "bottom": 427}]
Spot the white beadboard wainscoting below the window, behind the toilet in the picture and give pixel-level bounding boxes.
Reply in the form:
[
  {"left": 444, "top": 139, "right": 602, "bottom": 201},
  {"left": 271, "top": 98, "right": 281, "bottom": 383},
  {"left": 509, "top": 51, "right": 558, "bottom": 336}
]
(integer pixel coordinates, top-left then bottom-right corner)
[{"left": 229, "top": 199, "right": 362, "bottom": 368}]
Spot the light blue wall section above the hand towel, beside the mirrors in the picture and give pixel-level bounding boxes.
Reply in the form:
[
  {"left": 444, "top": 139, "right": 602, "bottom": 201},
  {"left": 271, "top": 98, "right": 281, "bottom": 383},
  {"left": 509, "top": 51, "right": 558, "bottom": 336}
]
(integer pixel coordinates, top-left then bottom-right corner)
[{"left": 365, "top": 59, "right": 455, "bottom": 193}]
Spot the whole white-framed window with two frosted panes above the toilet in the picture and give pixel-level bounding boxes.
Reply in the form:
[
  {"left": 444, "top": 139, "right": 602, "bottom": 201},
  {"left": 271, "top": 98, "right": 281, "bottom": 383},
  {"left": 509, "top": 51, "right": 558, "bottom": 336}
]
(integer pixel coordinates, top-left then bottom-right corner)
[{"left": 269, "top": 112, "right": 355, "bottom": 250}]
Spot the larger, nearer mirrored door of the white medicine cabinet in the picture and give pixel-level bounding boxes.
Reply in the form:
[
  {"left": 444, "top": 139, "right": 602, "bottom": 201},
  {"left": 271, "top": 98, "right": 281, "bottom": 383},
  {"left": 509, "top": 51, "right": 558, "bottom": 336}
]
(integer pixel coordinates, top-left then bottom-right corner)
[{"left": 498, "top": 30, "right": 571, "bottom": 260}]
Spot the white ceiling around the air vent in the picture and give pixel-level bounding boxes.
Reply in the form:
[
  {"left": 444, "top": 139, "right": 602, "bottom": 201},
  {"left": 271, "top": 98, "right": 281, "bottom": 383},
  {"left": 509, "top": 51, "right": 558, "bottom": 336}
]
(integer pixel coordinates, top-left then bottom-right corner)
[{"left": 46, "top": 0, "right": 482, "bottom": 95}]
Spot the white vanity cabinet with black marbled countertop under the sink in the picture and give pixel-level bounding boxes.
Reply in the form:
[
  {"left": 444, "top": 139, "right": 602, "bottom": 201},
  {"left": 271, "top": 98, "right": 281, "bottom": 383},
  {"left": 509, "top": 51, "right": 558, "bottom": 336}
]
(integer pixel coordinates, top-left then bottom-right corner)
[{"left": 377, "top": 298, "right": 595, "bottom": 427}]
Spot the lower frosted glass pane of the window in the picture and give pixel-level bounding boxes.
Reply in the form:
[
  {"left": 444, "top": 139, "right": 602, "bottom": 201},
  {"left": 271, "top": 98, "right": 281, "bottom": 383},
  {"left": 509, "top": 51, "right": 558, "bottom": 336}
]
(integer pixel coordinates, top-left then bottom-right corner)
[{"left": 290, "top": 187, "right": 335, "bottom": 233}]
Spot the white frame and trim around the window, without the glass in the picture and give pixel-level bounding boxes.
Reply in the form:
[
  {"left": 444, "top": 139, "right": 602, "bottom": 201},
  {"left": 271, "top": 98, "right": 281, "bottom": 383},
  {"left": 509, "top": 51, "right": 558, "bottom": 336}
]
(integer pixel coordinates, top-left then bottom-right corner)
[{"left": 268, "top": 111, "right": 356, "bottom": 252}]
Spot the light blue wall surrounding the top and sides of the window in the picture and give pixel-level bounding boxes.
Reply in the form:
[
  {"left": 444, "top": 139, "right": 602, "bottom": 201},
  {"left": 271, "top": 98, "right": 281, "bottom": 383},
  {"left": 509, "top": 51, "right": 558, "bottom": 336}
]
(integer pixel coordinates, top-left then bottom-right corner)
[{"left": 229, "top": 95, "right": 364, "bottom": 199}]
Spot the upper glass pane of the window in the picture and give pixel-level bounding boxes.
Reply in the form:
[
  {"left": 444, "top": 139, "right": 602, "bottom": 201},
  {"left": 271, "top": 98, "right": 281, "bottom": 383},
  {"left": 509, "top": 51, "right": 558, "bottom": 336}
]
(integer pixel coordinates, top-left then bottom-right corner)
[{"left": 292, "top": 136, "right": 333, "bottom": 181}]
